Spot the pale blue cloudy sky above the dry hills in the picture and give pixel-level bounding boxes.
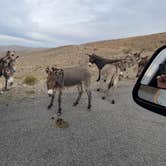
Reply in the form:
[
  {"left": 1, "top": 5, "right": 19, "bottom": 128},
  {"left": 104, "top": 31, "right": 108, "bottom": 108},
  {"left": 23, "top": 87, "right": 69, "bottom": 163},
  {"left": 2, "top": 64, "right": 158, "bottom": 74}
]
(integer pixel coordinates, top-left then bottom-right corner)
[{"left": 0, "top": 0, "right": 166, "bottom": 47}]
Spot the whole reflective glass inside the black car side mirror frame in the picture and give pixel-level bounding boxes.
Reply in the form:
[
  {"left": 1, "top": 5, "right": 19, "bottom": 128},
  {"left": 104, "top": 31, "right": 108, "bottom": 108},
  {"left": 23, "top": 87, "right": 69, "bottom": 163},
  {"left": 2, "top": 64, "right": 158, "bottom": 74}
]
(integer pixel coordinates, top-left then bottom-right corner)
[{"left": 138, "top": 48, "right": 166, "bottom": 107}]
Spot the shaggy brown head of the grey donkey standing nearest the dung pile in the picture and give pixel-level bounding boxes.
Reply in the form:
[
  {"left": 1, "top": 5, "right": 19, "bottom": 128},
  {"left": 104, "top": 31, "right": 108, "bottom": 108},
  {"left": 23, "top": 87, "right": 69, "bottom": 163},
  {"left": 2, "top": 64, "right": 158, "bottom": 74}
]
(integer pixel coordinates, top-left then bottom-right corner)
[{"left": 46, "top": 67, "right": 64, "bottom": 96}]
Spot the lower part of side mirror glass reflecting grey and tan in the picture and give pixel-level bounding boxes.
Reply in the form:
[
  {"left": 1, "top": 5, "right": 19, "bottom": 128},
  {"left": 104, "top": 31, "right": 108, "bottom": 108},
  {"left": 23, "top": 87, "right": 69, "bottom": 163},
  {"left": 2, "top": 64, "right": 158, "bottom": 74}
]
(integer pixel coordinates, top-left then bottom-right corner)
[{"left": 138, "top": 85, "right": 166, "bottom": 107}]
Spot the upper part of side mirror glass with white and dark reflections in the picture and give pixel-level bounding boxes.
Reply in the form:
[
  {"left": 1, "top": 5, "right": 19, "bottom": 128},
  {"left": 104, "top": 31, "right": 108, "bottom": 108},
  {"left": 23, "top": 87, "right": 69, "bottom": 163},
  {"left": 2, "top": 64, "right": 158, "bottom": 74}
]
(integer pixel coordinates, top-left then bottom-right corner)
[{"left": 141, "top": 49, "right": 166, "bottom": 89}]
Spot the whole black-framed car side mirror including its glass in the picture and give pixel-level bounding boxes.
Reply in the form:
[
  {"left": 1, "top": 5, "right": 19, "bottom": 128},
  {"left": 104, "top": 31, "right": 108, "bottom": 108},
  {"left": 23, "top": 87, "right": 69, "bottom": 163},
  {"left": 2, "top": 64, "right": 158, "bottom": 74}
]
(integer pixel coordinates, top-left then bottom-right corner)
[{"left": 132, "top": 45, "right": 166, "bottom": 116}]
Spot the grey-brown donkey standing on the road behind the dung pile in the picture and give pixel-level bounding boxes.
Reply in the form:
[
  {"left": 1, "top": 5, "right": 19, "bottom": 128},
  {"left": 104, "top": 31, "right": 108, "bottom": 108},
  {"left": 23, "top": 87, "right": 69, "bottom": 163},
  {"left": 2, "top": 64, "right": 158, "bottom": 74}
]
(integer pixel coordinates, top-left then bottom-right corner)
[{"left": 46, "top": 67, "right": 91, "bottom": 115}]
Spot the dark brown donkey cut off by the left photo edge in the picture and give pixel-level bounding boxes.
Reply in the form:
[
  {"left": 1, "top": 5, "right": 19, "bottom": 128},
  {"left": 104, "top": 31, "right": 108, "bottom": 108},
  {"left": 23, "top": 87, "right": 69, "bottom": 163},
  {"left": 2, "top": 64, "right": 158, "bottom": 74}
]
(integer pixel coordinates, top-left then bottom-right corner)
[{"left": 0, "top": 51, "right": 19, "bottom": 93}]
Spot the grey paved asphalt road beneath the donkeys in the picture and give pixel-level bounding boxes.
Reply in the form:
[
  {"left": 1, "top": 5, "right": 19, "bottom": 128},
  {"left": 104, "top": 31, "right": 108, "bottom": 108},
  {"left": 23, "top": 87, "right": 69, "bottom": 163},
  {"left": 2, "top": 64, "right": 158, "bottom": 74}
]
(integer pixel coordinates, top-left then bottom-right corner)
[{"left": 0, "top": 83, "right": 166, "bottom": 166}]
